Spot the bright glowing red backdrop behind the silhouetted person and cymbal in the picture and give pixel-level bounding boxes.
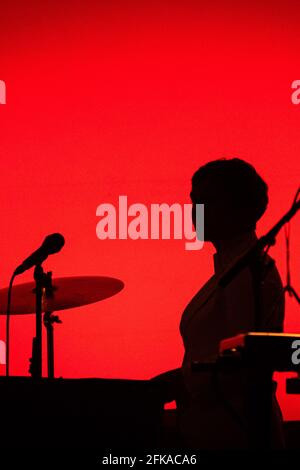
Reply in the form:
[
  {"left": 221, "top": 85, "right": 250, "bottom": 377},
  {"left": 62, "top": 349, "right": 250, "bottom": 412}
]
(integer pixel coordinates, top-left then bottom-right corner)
[{"left": 0, "top": 2, "right": 300, "bottom": 419}]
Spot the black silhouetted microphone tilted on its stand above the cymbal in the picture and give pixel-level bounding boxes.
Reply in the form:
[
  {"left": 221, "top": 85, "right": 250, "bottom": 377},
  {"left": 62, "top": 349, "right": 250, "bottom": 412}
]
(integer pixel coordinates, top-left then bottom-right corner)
[{"left": 14, "top": 233, "right": 65, "bottom": 276}]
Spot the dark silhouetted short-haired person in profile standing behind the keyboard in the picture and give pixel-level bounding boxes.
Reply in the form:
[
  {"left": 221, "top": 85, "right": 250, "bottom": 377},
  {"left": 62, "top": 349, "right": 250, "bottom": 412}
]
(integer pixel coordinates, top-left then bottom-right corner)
[{"left": 155, "top": 158, "right": 284, "bottom": 449}]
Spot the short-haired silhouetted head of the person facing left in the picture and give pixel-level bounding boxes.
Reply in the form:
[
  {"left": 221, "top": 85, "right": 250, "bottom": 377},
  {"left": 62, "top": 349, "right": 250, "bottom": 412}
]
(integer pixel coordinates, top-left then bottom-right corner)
[{"left": 191, "top": 158, "right": 268, "bottom": 241}]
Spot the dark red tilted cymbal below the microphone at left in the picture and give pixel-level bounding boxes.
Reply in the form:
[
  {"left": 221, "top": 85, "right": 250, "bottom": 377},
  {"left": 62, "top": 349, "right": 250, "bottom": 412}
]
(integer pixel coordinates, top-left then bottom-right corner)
[{"left": 0, "top": 276, "right": 124, "bottom": 315}]
